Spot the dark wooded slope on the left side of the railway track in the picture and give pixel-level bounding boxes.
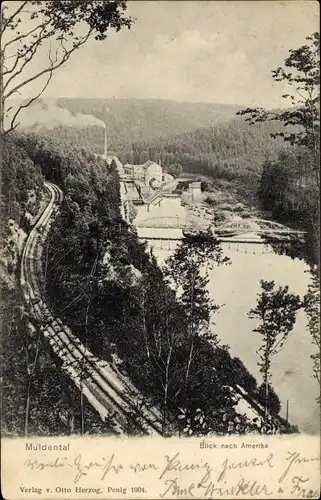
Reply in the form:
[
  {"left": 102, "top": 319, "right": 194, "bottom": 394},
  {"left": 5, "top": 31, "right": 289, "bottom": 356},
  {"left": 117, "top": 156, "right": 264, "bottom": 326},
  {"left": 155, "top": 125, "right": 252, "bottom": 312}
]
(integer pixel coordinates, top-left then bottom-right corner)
[{"left": 0, "top": 135, "right": 110, "bottom": 436}]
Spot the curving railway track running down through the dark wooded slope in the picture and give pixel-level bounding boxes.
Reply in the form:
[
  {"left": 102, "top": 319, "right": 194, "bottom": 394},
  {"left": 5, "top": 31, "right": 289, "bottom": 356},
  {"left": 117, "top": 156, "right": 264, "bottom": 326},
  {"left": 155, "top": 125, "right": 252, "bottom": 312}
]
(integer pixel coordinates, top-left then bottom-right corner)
[{"left": 21, "top": 182, "right": 161, "bottom": 435}]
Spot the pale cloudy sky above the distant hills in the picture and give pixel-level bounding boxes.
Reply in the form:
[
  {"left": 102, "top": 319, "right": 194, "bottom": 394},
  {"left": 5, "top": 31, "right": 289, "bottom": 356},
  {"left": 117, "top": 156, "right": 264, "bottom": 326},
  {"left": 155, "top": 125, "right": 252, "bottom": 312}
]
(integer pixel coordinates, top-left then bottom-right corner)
[{"left": 3, "top": 0, "right": 319, "bottom": 108}]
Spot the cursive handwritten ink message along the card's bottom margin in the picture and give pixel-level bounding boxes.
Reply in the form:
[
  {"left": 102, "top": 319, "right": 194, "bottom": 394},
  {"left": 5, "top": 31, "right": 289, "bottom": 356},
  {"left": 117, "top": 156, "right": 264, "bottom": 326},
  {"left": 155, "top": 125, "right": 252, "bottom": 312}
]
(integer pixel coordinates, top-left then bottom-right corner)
[{"left": 24, "top": 450, "right": 320, "bottom": 499}]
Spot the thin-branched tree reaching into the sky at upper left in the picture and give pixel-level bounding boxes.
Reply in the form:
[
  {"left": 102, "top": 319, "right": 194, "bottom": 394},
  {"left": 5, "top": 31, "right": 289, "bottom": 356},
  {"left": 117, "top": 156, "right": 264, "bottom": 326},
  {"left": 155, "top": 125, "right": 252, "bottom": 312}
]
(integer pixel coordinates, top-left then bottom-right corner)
[{"left": 0, "top": 0, "right": 132, "bottom": 133}]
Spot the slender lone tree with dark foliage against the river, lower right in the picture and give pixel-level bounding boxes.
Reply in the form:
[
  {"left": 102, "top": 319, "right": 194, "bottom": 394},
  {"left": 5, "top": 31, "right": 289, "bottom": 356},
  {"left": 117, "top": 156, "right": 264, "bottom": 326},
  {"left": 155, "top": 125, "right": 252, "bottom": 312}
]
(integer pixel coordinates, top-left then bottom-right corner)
[{"left": 248, "top": 280, "right": 302, "bottom": 418}]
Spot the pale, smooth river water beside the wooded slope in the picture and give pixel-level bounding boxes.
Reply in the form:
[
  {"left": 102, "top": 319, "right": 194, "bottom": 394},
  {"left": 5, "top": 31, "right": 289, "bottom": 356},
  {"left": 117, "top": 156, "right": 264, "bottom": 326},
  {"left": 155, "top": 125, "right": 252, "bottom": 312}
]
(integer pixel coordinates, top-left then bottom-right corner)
[{"left": 134, "top": 198, "right": 320, "bottom": 434}]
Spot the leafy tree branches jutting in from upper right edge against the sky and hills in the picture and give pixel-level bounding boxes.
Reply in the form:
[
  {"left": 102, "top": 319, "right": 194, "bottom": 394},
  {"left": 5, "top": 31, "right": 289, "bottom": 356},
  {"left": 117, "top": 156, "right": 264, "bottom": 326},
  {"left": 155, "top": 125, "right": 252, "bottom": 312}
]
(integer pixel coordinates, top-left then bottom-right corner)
[{"left": 237, "top": 33, "right": 320, "bottom": 186}]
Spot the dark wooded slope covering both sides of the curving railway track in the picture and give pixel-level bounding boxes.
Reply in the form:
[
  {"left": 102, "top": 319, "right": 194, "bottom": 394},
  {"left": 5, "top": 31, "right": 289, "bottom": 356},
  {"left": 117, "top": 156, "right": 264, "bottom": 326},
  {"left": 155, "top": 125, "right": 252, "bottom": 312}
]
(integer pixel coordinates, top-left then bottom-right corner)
[{"left": 2, "top": 134, "right": 290, "bottom": 435}]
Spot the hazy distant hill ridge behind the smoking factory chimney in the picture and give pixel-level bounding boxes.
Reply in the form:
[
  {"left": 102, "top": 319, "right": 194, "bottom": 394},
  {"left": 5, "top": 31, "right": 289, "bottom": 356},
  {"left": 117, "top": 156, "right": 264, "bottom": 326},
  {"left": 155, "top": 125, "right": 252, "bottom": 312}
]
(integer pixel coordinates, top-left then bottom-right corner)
[{"left": 14, "top": 98, "right": 242, "bottom": 148}]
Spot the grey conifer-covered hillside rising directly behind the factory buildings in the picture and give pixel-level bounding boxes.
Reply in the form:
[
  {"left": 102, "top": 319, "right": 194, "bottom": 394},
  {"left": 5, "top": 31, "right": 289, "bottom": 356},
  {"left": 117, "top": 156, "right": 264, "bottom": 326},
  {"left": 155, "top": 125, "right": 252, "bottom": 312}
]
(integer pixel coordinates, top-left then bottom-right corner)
[{"left": 119, "top": 120, "right": 282, "bottom": 180}]
